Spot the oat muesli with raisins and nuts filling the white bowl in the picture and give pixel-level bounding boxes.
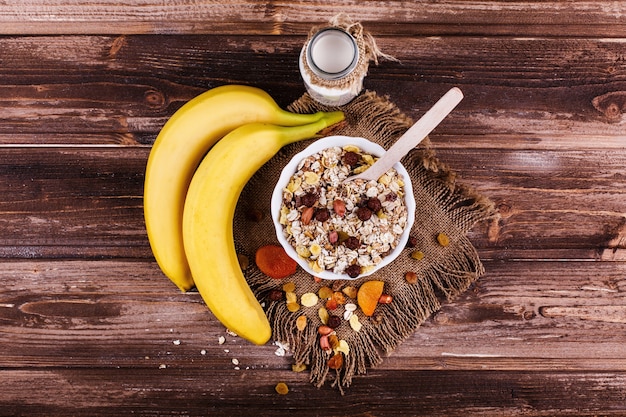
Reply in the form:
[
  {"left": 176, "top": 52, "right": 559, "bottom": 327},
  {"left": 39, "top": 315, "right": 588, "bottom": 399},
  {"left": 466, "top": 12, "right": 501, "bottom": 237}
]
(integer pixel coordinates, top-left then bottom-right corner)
[{"left": 279, "top": 145, "right": 407, "bottom": 278}]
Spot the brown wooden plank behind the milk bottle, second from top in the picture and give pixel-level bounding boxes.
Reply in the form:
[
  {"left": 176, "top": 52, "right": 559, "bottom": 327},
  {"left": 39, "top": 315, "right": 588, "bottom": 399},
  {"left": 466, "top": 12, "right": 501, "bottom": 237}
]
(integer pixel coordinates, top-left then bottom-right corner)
[{"left": 0, "top": 36, "right": 626, "bottom": 145}]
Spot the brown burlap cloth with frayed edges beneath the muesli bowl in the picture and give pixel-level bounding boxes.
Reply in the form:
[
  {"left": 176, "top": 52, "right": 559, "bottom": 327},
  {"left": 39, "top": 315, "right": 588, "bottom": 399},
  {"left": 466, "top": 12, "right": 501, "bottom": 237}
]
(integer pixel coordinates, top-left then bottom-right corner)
[{"left": 235, "top": 87, "right": 494, "bottom": 392}]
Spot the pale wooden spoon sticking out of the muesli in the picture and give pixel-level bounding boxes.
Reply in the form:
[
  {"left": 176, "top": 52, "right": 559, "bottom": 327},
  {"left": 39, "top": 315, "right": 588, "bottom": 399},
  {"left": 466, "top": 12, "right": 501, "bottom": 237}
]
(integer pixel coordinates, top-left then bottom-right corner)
[{"left": 346, "top": 87, "right": 463, "bottom": 181}]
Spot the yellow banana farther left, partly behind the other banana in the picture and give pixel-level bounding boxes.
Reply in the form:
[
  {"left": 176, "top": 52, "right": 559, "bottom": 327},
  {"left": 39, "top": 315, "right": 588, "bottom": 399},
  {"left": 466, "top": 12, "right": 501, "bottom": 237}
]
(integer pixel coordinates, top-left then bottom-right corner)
[{"left": 144, "top": 85, "right": 324, "bottom": 291}]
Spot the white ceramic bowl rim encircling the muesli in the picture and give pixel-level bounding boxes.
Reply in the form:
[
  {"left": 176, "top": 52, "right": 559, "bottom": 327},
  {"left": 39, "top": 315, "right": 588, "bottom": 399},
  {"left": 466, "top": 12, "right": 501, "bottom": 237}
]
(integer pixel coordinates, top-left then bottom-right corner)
[{"left": 271, "top": 136, "right": 415, "bottom": 280}]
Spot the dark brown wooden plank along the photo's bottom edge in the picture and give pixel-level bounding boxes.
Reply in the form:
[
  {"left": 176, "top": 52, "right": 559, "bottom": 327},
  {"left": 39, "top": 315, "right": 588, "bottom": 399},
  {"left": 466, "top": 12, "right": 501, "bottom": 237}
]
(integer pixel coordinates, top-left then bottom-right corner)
[{"left": 0, "top": 368, "right": 626, "bottom": 417}]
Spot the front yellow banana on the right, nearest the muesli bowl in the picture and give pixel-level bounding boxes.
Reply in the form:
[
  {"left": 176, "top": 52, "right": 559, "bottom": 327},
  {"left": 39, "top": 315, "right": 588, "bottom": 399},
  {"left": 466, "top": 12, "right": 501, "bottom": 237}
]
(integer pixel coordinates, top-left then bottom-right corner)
[{"left": 183, "top": 112, "right": 344, "bottom": 345}]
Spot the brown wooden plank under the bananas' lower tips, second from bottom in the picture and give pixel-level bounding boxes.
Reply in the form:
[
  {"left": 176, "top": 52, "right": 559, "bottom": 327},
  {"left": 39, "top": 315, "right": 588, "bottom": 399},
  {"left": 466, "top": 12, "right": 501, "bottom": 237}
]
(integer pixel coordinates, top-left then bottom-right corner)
[{"left": 0, "top": 260, "right": 626, "bottom": 370}]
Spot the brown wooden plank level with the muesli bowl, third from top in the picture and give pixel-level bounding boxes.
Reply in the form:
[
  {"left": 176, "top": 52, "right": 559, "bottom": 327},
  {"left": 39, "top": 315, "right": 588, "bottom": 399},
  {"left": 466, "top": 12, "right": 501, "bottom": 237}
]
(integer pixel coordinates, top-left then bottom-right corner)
[{"left": 0, "top": 146, "right": 626, "bottom": 260}]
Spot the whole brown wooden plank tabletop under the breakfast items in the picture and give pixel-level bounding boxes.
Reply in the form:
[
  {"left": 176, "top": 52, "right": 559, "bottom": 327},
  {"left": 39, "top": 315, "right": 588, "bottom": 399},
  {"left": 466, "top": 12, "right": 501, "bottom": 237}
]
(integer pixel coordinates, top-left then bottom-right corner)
[{"left": 0, "top": 0, "right": 626, "bottom": 416}]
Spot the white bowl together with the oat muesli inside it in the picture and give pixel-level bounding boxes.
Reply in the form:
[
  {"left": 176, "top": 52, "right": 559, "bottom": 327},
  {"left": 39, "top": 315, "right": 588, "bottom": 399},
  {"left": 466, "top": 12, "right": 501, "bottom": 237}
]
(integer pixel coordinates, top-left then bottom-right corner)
[{"left": 272, "top": 136, "right": 415, "bottom": 279}]
